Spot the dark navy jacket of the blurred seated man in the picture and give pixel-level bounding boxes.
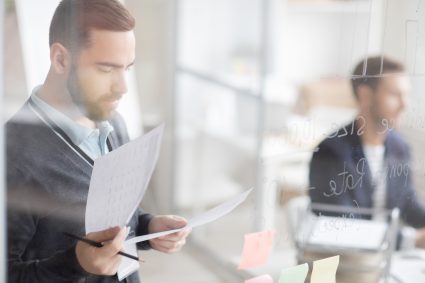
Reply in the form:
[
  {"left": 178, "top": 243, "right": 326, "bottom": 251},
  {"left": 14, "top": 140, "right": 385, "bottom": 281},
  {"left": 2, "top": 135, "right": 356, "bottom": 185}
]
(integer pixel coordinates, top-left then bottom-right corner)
[{"left": 309, "top": 122, "right": 425, "bottom": 228}]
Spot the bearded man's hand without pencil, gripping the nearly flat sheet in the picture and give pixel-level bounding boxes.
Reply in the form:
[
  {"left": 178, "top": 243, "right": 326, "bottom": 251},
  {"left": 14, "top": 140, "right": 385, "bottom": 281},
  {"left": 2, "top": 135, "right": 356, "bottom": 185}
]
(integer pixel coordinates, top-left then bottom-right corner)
[{"left": 148, "top": 215, "right": 191, "bottom": 253}]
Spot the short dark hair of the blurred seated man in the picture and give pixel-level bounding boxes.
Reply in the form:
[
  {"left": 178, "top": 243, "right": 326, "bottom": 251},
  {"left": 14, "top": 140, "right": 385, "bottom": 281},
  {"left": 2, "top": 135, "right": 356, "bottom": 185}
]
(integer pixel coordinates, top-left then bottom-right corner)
[{"left": 351, "top": 56, "right": 405, "bottom": 98}]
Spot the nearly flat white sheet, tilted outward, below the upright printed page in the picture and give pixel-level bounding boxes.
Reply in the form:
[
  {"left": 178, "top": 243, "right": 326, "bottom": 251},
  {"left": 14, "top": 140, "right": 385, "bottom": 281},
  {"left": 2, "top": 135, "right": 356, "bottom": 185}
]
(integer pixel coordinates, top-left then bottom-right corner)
[{"left": 126, "top": 189, "right": 253, "bottom": 244}]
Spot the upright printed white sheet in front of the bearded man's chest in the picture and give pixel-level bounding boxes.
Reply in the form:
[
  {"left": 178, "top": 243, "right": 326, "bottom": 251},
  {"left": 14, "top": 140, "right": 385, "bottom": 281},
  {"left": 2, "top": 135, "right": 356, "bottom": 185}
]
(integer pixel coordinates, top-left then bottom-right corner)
[{"left": 85, "top": 125, "right": 164, "bottom": 233}]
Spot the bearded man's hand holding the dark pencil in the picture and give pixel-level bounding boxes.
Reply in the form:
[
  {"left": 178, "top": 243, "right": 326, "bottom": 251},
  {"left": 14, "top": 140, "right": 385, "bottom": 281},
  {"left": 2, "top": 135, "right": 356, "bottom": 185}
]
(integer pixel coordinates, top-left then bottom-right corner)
[{"left": 75, "top": 227, "right": 127, "bottom": 275}]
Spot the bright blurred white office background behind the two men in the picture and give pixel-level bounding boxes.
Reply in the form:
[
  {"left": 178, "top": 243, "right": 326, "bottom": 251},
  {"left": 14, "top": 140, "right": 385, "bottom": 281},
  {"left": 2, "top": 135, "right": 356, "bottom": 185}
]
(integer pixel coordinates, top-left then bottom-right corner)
[{"left": 0, "top": 0, "right": 425, "bottom": 283}]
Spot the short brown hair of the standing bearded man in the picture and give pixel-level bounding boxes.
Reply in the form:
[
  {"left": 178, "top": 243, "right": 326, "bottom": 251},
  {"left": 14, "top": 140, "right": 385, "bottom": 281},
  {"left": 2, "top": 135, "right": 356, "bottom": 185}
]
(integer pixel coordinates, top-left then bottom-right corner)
[{"left": 49, "top": 0, "right": 136, "bottom": 51}]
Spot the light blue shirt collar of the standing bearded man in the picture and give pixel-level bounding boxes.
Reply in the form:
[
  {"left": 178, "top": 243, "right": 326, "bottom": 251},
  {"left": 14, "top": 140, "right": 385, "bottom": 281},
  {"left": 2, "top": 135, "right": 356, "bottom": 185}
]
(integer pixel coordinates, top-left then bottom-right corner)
[{"left": 30, "top": 86, "right": 114, "bottom": 146}]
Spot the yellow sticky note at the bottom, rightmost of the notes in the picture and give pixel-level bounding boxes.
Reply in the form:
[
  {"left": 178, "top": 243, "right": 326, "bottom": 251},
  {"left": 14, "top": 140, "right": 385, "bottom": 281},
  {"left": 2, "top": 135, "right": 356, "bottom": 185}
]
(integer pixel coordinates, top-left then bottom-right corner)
[{"left": 310, "top": 255, "right": 339, "bottom": 283}]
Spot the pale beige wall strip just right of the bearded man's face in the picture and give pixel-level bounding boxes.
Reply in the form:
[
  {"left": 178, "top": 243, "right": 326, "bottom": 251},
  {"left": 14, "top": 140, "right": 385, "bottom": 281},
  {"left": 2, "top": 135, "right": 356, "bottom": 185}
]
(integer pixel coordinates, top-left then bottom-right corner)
[{"left": 127, "top": 0, "right": 176, "bottom": 213}]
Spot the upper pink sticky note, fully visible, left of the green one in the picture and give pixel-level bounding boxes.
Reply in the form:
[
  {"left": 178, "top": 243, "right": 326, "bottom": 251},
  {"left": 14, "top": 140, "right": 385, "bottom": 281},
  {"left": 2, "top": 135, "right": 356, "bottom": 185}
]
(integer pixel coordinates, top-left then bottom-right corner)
[{"left": 238, "top": 231, "right": 274, "bottom": 269}]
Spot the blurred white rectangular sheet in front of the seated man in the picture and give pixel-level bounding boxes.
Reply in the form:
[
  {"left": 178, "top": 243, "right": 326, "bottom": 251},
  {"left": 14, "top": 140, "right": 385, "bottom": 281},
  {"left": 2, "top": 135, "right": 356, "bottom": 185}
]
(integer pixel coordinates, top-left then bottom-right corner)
[{"left": 308, "top": 216, "right": 388, "bottom": 250}]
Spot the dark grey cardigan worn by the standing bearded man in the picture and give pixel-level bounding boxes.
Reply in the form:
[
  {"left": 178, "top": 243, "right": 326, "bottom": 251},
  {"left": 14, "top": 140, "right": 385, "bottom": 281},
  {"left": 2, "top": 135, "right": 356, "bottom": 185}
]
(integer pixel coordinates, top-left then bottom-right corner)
[{"left": 6, "top": 101, "right": 152, "bottom": 283}]
